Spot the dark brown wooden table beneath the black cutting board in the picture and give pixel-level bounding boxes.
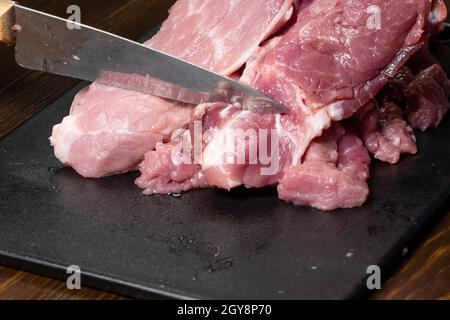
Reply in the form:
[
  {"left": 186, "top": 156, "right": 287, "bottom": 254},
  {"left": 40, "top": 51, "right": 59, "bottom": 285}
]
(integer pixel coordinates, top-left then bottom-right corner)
[{"left": 0, "top": 0, "right": 450, "bottom": 299}]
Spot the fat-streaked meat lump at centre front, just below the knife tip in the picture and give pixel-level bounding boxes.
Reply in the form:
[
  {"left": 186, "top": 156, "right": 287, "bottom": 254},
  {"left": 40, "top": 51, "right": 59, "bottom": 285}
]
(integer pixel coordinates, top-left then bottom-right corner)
[{"left": 202, "top": 105, "right": 283, "bottom": 190}]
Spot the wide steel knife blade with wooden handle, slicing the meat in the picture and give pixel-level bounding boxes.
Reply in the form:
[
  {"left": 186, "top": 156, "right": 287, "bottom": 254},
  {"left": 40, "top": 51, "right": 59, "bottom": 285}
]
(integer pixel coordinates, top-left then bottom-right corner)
[{"left": 0, "top": 0, "right": 289, "bottom": 113}]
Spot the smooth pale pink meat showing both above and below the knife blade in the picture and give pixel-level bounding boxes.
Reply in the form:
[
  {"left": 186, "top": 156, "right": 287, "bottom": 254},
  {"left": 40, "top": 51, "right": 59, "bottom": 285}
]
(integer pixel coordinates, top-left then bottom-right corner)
[{"left": 50, "top": 0, "right": 293, "bottom": 178}]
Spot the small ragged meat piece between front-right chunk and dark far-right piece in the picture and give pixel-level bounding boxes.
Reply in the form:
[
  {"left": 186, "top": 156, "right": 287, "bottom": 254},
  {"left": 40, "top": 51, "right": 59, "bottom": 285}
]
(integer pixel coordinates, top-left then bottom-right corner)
[{"left": 359, "top": 101, "right": 417, "bottom": 164}]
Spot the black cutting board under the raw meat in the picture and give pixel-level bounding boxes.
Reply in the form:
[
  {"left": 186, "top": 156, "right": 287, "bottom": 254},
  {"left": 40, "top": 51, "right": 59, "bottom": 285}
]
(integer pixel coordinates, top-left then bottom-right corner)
[{"left": 0, "top": 49, "right": 450, "bottom": 299}]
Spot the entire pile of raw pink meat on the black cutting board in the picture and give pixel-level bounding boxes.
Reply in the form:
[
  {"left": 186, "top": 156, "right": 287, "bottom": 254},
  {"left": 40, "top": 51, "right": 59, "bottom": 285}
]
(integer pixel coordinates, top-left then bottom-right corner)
[{"left": 52, "top": 0, "right": 450, "bottom": 210}]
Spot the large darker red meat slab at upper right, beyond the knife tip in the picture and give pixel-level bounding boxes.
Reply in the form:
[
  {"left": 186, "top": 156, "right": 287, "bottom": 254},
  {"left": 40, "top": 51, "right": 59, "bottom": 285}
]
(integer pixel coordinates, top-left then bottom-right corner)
[{"left": 244, "top": 0, "right": 431, "bottom": 120}]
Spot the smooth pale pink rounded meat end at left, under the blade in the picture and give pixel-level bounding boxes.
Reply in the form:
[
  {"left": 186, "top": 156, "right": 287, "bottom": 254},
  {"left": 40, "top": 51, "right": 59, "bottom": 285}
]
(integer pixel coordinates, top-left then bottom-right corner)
[{"left": 50, "top": 84, "right": 192, "bottom": 178}]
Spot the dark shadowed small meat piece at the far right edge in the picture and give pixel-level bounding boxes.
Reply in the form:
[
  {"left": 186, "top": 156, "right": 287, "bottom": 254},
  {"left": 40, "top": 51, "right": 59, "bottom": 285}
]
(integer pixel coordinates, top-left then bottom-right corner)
[{"left": 405, "top": 64, "right": 450, "bottom": 131}]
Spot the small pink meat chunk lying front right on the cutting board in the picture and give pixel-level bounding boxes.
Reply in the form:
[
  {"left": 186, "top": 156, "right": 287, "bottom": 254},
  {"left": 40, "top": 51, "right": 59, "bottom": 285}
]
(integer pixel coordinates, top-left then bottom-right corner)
[{"left": 278, "top": 124, "right": 370, "bottom": 210}]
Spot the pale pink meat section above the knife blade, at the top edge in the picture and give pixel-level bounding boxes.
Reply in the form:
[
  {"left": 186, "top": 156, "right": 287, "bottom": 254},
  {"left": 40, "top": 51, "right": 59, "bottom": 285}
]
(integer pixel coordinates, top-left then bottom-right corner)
[{"left": 147, "top": 0, "right": 293, "bottom": 75}]
